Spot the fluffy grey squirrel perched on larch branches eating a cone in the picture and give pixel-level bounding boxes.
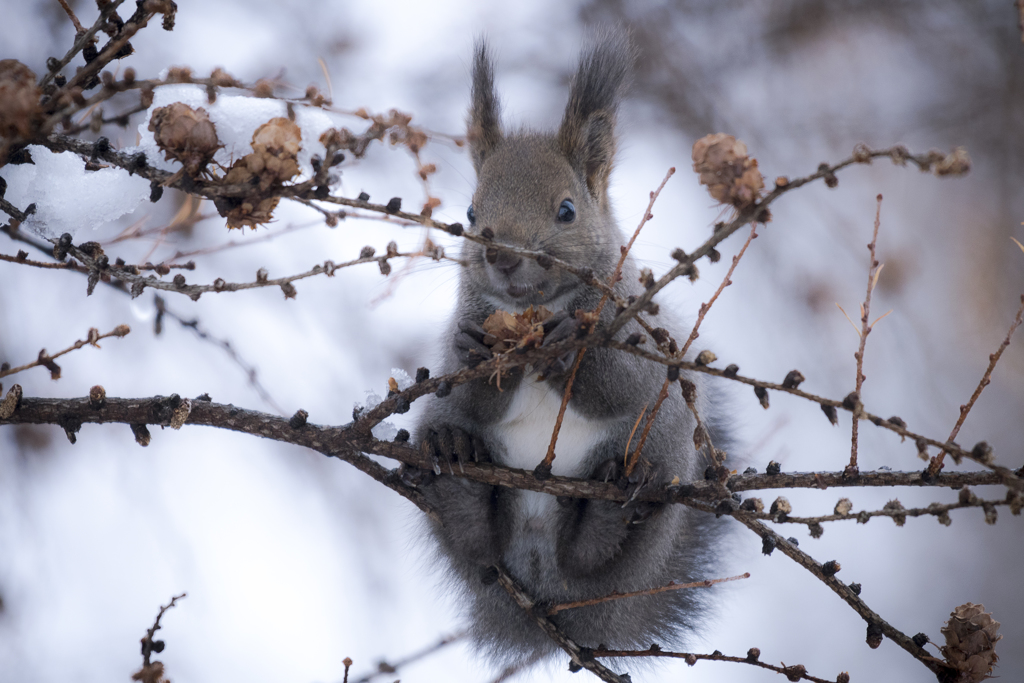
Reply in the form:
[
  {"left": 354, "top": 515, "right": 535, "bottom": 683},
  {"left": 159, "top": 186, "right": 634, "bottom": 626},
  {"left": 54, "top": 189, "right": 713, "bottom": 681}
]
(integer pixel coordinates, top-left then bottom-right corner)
[{"left": 414, "top": 33, "right": 722, "bottom": 665}]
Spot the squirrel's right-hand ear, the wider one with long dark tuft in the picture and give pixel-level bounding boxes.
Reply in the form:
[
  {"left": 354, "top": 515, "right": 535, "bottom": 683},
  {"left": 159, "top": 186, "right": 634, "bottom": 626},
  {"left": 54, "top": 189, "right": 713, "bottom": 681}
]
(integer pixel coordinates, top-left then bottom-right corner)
[{"left": 558, "top": 31, "right": 636, "bottom": 203}]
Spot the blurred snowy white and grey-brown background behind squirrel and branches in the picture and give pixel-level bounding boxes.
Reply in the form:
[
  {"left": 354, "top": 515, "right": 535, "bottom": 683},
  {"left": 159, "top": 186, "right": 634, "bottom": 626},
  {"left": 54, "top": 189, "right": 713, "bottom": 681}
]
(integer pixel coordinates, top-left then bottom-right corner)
[{"left": 0, "top": 0, "right": 1024, "bottom": 683}]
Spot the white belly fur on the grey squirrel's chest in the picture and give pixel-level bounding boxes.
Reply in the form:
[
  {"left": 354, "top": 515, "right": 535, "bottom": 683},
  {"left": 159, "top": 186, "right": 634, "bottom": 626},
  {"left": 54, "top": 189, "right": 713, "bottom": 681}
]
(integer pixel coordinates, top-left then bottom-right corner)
[{"left": 495, "top": 377, "right": 610, "bottom": 518}]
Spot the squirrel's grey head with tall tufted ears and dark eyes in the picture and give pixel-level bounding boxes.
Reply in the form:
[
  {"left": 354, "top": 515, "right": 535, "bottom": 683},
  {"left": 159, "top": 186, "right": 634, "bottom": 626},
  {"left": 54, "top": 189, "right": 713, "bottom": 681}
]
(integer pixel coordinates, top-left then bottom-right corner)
[{"left": 463, "top": 34, "right": 634, "bottom": 309}]
